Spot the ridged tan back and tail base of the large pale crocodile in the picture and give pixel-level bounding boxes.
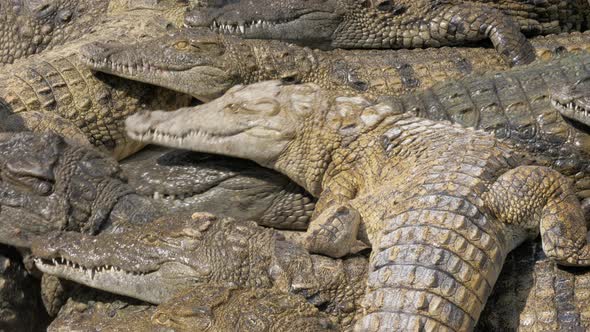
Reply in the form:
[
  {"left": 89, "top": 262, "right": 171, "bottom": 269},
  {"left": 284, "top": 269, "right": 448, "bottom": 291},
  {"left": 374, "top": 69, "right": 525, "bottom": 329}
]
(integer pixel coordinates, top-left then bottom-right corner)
[{"left": 346, "top": 118, "right": 527, "bottom": 331}]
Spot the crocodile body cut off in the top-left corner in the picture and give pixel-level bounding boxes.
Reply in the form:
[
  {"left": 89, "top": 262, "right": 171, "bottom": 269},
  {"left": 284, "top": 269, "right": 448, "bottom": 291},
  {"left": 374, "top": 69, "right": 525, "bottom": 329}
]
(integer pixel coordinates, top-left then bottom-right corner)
[{"left": 0, "top": 0, "right": 192, "bottom": 67}]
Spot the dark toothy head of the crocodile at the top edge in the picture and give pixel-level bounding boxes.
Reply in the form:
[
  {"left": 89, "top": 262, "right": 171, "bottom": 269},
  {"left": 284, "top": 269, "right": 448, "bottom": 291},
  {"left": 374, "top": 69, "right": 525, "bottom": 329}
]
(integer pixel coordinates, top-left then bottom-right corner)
[{"left": 185, "top": 0, "right": 344, "bottom": 47}]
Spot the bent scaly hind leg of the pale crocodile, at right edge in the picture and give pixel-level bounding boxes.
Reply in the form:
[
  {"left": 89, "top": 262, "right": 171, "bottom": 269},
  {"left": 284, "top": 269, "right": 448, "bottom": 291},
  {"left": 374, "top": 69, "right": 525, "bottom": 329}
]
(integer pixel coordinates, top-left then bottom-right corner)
[{"left": 484, "top": 166, "right": 590, "bottom": 266}]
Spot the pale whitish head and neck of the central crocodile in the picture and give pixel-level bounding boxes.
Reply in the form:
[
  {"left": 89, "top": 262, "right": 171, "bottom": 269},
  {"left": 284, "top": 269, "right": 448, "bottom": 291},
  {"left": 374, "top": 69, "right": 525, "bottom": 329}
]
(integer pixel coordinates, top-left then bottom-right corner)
[{"left": 125, "top": 81, "right": 391, "bottom": 196}]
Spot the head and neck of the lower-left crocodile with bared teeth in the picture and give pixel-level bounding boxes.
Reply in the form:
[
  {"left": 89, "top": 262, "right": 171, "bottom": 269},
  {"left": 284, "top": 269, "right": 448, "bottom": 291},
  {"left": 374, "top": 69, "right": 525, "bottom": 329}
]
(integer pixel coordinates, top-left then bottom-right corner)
[{"left": 32, "top": 213, "right": 280, "bottom": 303}]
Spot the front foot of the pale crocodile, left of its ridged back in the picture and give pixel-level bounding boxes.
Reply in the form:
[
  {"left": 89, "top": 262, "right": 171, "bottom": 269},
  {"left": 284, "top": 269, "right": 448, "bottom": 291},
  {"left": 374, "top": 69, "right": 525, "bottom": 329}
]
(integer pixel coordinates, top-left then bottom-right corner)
[{"left": 305, "top": 205, "right": 368, "bottom": 258}]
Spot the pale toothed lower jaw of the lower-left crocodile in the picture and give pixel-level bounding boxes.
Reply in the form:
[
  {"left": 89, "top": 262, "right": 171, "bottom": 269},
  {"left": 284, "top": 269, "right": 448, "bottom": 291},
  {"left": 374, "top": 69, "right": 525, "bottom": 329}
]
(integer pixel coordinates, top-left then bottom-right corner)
[{"left": 35, "top": 258, "right": 194, "bottom": 304}]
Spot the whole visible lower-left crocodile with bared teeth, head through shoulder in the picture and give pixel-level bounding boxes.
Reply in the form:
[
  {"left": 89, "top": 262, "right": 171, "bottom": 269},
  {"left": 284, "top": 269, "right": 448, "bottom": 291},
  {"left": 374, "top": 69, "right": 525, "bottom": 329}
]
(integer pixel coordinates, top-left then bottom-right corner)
[{"left": 31, "top": 212, "right": 367, "bottom": 328}]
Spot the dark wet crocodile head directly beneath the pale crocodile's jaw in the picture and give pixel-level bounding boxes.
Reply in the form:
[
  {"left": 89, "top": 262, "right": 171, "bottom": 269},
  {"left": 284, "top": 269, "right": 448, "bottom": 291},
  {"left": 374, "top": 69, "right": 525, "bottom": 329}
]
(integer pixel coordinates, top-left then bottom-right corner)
[{"left": 121, "top": 146, "right": 315, "bottom": 230}]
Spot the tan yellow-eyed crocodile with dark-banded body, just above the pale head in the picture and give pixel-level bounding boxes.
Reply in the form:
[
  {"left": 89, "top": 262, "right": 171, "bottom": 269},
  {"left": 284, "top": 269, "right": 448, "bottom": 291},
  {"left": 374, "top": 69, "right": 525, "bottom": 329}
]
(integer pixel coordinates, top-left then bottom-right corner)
[{"left": 81, "top": 29, "right": 590, "bottom": 101}]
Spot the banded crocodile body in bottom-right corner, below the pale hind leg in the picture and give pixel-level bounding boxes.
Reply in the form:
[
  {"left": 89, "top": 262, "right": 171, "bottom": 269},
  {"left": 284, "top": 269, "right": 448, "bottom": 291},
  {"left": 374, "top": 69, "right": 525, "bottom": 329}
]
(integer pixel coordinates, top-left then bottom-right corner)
[{"left": 476, "top": 242, "right": 590, "bottom": 332}]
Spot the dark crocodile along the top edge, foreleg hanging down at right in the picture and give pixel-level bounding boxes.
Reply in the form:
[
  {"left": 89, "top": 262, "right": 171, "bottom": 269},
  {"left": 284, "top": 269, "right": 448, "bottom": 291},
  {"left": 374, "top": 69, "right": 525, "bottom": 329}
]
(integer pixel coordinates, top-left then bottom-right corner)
[{"left": 186, "top": 0, "right": 535, "bottom": 65}]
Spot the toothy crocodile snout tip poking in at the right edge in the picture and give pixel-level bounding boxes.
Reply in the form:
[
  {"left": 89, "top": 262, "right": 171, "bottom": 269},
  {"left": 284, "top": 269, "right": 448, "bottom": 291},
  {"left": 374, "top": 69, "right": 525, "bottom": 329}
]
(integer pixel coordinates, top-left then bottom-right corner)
[{"left": 551, "top": 76, "right": 590, "bottom": 127}]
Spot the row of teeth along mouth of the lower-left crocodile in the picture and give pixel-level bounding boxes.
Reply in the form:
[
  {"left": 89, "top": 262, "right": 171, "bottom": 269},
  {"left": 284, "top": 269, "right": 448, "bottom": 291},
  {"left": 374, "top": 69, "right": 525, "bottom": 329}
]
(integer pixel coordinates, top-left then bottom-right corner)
[{"left": 34, "top": 257, "right": 149, "bottom": 280}]
